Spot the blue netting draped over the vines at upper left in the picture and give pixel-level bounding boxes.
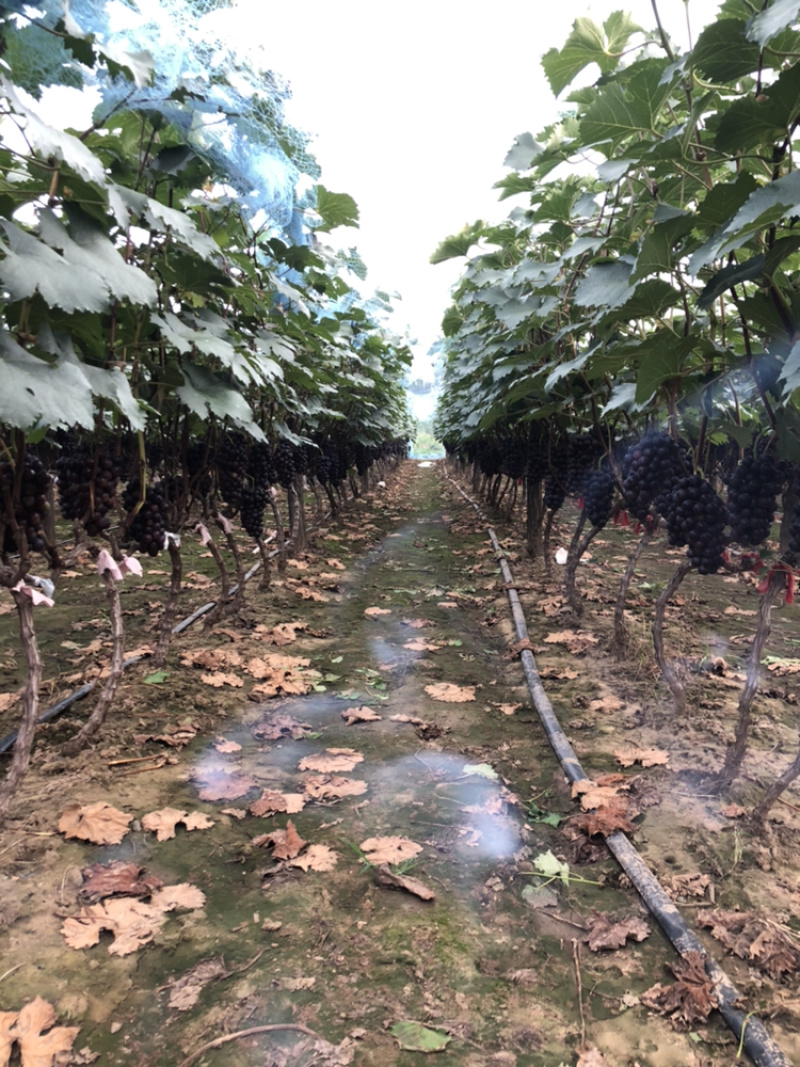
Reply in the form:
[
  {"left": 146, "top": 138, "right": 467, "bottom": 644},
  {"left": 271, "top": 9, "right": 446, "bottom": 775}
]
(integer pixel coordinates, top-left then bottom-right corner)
[{"left": 0, "top": 0, "right": 319, "bottom": 236}]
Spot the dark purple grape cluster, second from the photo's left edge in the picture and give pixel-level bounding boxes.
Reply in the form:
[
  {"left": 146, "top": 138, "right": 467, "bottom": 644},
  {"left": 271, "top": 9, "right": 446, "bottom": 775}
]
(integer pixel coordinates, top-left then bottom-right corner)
[{"left": 55, "top": 445, "right": 119, "bottom": 537}]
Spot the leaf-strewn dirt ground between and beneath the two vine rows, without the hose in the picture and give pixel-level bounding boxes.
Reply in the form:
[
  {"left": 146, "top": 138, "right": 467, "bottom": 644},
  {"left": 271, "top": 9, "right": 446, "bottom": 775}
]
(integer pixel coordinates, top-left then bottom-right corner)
[{"left": 0, "top": 462, "right": 800, "bottom": 1067}]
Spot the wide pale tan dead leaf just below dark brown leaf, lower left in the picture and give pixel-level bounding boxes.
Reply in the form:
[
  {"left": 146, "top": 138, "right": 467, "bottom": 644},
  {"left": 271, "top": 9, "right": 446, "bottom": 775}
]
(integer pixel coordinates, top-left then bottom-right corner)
[{"left": 61, "top": 882, "right": 206, "bottom": 956}]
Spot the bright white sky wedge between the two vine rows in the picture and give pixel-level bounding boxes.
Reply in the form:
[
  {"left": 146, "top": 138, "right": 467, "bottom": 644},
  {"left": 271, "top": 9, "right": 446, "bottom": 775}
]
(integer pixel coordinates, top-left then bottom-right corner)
[{"left": 230, "top": 0, "right": 719, "bottom": 367}]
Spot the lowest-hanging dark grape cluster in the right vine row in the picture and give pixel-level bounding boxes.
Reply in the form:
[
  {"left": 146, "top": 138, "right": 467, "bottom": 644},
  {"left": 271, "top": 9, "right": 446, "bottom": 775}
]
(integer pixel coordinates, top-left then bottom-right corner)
[{"left": 665, "top": 474, "right": 727, "bottom": 574}]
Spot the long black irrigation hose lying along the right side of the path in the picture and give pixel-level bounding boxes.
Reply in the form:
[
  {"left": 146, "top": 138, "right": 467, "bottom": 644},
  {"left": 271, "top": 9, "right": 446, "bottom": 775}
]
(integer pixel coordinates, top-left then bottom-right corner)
[{"left": 445, "top": 464, "right": 790, "bottom": 1067}]
